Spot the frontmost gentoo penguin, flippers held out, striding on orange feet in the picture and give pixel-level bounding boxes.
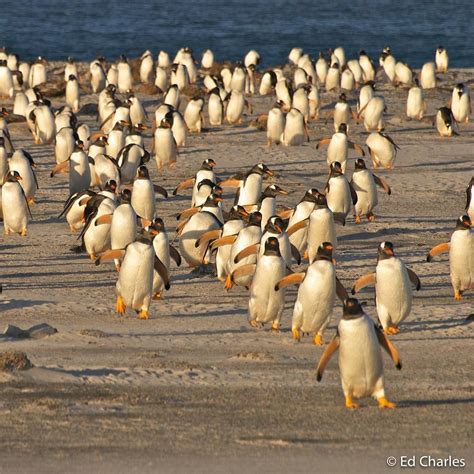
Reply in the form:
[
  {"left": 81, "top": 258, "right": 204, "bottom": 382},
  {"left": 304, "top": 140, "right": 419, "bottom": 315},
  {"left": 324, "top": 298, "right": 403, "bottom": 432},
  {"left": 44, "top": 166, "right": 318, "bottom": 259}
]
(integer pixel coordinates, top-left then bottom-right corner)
[{"left": 316, "top": 298, "right": 402, "bottom": 409}]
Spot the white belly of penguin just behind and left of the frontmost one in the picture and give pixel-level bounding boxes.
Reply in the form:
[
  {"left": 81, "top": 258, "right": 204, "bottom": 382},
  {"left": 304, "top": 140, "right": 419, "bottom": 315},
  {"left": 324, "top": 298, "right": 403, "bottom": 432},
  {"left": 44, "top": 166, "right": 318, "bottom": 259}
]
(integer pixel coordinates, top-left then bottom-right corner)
[{"left": 291, "top": 260, "right": 336, "bottom": 335}]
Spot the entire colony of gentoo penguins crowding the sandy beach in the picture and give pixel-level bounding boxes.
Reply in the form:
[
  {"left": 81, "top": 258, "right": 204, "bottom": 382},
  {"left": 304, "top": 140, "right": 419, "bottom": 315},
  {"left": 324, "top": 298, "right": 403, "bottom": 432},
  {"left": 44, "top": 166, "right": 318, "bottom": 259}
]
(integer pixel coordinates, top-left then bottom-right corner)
[{"left": 0, "top": 43, "right": 474, "bottom": 408}]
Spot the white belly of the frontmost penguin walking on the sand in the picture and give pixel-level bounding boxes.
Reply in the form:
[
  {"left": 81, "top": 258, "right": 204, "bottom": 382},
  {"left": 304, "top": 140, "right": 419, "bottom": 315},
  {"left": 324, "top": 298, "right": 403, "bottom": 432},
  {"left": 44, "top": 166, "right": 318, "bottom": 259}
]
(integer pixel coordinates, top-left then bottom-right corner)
[{"left": 338, "top": 315, "right": 385, "bottom": 398}]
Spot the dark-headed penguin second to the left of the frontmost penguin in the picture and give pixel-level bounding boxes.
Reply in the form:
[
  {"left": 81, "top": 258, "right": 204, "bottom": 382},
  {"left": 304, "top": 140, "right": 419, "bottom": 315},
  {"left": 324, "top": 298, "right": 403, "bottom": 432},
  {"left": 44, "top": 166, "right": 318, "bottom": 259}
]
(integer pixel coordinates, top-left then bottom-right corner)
[{"left": 248, "top": 237, "right": 287, "bottom": 331}]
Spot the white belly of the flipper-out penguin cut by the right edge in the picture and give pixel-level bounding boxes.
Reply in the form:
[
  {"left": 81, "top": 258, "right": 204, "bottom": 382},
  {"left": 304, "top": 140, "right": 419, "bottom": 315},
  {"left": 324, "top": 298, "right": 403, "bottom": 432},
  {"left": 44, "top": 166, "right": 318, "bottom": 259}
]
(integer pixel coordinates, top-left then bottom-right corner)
[{"left": 449, "top": 230, "right": 474, "bottom": 291}]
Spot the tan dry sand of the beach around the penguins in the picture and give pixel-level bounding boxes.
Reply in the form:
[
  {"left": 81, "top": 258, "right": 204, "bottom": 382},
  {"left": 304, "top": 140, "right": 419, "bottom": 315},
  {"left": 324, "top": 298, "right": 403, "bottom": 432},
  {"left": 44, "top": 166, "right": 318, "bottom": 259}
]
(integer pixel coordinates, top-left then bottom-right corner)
[{"left": 0, "top": 64, "right": 474, "bottom": 472}]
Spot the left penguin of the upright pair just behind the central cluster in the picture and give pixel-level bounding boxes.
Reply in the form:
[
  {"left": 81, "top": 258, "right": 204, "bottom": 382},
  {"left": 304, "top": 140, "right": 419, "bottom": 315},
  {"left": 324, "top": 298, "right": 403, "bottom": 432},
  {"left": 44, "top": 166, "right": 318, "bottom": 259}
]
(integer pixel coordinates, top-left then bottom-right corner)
[{"left": 324, "top": 161, "right": 357, "bottom": 225}]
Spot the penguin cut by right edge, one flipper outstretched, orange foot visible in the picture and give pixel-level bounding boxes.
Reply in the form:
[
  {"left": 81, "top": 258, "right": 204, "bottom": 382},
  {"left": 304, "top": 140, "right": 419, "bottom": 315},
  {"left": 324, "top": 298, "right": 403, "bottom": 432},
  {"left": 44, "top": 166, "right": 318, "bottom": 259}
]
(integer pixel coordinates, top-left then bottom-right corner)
[{"left": 427, "top": 215, "right": 474, "bottom": 300}]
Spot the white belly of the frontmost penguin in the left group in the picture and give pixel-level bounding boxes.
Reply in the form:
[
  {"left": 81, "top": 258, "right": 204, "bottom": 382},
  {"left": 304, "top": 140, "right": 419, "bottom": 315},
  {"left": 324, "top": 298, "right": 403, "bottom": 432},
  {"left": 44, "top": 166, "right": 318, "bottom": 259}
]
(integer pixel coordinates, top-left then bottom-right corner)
[{"left": 116, "top": 242, "right": 154, "bottom": 311}]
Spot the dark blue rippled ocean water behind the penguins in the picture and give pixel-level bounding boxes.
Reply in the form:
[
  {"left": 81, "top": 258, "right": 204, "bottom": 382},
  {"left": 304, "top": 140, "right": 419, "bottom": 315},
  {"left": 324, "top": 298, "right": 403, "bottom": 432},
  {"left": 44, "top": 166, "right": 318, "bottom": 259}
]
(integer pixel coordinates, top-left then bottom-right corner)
[{"left": 0, "top": 0, "right": 474, "bottom": 67}]
